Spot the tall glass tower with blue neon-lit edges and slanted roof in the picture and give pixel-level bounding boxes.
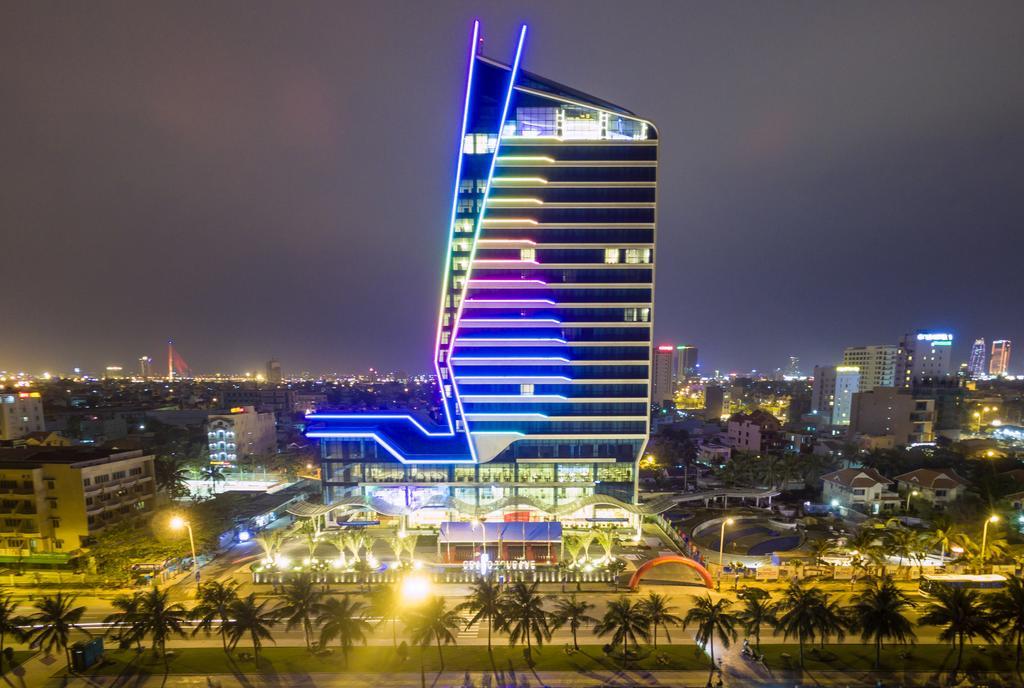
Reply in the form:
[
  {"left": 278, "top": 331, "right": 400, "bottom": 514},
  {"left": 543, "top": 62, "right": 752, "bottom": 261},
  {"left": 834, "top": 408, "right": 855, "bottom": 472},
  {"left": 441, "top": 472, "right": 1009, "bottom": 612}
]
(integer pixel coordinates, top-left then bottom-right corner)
[{"left": 307, "top": 21, "right": 657, "bottom": 523}]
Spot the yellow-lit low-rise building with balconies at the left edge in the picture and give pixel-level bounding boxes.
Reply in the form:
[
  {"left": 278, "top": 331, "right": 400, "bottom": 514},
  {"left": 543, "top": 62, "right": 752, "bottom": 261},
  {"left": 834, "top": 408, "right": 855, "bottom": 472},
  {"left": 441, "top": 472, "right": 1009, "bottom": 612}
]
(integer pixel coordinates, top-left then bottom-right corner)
[{"left": 0, "top": 446, "right": 156, "bottom": 563}]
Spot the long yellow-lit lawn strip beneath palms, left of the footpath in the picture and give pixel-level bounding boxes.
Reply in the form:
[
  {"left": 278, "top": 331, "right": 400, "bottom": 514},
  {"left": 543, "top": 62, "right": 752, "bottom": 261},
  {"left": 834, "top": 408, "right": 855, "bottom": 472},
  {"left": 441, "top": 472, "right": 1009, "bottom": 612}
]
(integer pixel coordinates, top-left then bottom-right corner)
[{"left": 72, "top": 645, "right": 709, "bottom": 676}]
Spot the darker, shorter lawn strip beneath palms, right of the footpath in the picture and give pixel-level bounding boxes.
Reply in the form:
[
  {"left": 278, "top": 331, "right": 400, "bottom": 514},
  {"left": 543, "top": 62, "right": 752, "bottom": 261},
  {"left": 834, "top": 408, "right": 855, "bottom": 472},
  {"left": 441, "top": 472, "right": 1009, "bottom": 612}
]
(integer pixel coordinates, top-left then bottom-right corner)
[{"left": 761, "top": 644, "right": 1014, "bottom": 672}]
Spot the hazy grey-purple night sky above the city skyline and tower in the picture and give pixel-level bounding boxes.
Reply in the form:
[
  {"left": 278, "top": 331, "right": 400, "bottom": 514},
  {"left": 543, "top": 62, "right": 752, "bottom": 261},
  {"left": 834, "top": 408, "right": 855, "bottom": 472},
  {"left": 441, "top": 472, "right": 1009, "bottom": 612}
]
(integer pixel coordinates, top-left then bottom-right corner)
[{"left": 0, "top": 0, "right": 1024, "bottom": 373}]
